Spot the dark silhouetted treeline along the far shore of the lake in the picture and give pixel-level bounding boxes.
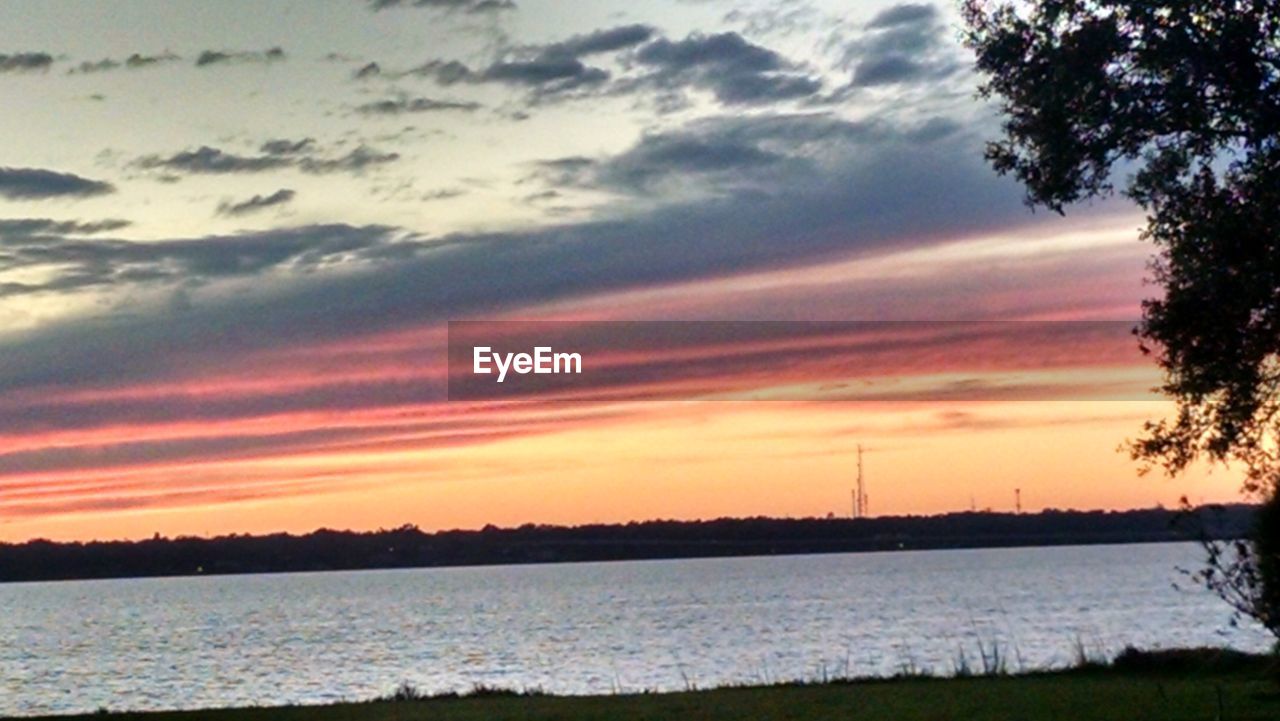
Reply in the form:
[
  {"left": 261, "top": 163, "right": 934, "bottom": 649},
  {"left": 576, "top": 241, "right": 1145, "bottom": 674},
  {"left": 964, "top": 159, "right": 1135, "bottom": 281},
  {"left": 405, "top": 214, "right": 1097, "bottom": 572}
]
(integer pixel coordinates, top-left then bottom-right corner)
[{"left": 0, "top": 503, "right": 1256, "bottom": 583}]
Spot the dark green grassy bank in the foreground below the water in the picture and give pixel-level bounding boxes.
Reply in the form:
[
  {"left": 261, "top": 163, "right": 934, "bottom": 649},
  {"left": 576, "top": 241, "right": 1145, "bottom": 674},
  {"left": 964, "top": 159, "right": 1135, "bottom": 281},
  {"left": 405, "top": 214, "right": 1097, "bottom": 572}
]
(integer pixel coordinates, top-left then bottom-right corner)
[{"left": 20, "top": 652, "right": 1280, "bottom": 721}]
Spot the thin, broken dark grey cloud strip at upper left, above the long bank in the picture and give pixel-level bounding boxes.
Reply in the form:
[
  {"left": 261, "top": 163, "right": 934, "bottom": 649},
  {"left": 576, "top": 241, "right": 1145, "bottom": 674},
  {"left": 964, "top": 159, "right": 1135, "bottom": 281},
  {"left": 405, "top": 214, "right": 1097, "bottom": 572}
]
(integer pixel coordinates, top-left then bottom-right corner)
[{"left": 133, "top": 138, "right": 399, "bottom": 175}]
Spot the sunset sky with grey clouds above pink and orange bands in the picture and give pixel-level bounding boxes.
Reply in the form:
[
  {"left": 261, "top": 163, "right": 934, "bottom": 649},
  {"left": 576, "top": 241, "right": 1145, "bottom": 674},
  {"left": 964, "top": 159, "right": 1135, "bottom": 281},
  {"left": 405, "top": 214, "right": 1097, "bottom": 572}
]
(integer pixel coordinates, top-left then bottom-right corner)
[{"left": 0, "top": 0, "right": 1239, "bottom": 540}]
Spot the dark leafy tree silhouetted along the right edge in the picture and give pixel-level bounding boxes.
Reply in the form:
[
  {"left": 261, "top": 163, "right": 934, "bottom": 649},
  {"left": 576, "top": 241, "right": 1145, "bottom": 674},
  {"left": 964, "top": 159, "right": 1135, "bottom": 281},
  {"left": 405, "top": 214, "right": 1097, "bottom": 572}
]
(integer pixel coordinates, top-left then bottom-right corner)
[{"left": 963, "top": 0, "right": 1280, "bottom": 635}]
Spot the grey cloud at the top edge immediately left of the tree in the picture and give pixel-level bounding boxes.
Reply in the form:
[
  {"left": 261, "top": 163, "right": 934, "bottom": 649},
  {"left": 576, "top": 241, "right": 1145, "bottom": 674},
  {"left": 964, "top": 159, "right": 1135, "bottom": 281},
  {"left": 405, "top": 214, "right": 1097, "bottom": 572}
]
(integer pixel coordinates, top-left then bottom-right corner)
[{"left": 845, "top": 4, "right": 961, "bottom": 87}]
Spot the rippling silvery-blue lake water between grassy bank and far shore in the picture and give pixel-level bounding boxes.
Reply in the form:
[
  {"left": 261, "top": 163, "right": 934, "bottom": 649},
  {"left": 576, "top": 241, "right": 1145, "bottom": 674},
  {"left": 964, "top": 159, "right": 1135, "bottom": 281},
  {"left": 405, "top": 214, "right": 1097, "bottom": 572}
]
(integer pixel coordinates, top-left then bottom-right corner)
[{"left": 0, "top": 544, "right": 1267, "bottom": 715}]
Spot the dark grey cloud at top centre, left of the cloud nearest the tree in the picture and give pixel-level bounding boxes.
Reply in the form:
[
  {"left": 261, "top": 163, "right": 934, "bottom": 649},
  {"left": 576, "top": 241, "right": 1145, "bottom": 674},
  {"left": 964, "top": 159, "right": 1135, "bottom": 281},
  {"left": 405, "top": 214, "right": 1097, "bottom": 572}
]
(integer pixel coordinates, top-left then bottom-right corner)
[{"left": 635, "top": 32, "right": 822, "bottom": 105}]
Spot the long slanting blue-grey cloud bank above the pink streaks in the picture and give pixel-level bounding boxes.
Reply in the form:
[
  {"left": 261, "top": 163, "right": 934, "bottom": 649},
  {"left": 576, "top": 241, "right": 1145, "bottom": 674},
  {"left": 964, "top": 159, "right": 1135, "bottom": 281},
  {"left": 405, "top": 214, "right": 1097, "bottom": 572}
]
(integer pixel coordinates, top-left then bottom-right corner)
[{"left": 0, "top": 114, "right": 1049, "bottom": 399}]
